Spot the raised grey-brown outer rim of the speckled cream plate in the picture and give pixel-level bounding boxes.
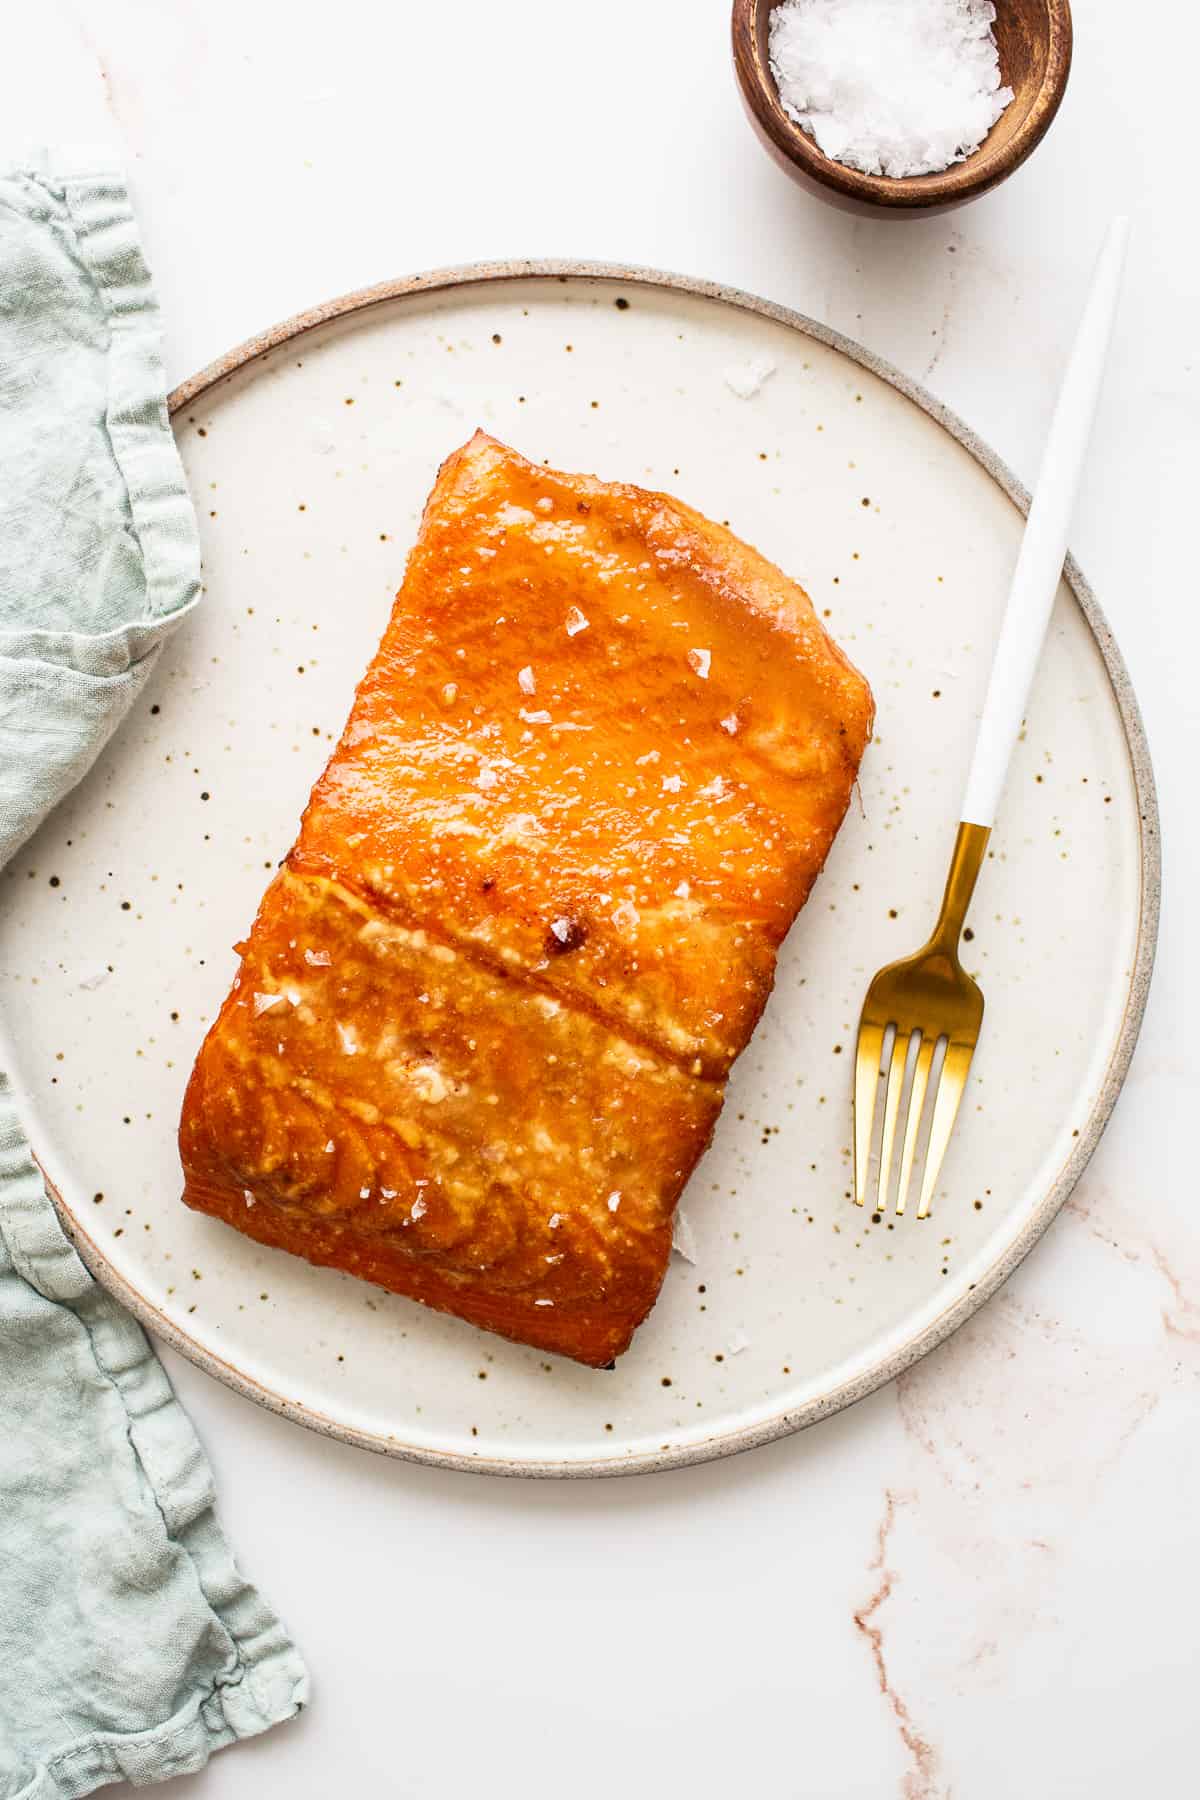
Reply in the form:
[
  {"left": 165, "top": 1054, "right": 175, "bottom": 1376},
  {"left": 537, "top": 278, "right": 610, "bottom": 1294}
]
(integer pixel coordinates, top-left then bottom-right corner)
[{"left": 47, "top": 257, "right": 1162, "bottom": 1480}]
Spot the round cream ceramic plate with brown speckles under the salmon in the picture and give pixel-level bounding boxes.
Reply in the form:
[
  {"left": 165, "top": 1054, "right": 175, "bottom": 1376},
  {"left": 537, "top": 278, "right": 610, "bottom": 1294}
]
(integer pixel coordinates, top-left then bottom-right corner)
[{"left": 0, "top": 265, "right": 1157, "bottom": 1474}]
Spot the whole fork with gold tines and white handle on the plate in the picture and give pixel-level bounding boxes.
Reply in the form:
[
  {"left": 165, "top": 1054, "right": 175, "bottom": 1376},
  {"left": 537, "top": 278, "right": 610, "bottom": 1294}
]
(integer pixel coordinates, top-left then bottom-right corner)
[{"left": 855, "top": 218, "right": 1128, "bottom": 1219}]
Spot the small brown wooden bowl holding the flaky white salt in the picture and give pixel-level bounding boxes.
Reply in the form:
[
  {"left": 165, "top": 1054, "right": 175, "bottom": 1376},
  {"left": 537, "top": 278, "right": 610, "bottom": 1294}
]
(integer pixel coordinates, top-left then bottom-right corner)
[{"left": 732, "top": 0, "right": 1070, "bottom": 218}]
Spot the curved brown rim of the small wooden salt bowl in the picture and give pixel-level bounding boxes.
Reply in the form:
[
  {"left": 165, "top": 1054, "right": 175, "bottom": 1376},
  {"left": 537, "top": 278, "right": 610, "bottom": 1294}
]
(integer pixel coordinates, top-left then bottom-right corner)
[{"left": 732, "top": 0, "right": 1074, "bottom": 209}]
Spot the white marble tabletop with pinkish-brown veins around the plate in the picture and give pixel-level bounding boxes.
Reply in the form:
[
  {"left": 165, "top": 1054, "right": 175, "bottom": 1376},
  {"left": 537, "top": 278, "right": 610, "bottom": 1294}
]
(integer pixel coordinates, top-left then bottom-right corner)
[{"left": 0, "top": 0, "right": 1200, "bottom": 1800}]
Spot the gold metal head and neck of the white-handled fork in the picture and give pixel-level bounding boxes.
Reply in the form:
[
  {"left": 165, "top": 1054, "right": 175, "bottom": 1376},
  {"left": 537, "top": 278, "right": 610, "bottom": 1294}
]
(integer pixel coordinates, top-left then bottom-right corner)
[{"left": 855, "top": 824, "right": 991, "bottom": 1219}]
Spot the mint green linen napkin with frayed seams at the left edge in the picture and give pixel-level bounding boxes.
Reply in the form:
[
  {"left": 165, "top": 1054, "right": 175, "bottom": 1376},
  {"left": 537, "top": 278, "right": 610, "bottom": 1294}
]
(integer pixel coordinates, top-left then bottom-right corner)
[{"left": 0, "top": 160, "right": 308, "bottom": 1800}]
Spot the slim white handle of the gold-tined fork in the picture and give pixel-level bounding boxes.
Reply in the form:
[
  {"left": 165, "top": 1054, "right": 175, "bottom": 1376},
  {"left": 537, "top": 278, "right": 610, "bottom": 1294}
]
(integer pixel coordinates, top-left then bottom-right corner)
[{"left": 963, "top": 218, "right": 1130, "bottom": 828}]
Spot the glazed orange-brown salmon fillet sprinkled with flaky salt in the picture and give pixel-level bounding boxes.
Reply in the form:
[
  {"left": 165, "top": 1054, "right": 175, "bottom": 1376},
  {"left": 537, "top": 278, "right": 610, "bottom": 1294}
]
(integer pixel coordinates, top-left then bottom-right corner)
[{"left": 180, "top": 432, "right": 873, "bottom": 1364}]
